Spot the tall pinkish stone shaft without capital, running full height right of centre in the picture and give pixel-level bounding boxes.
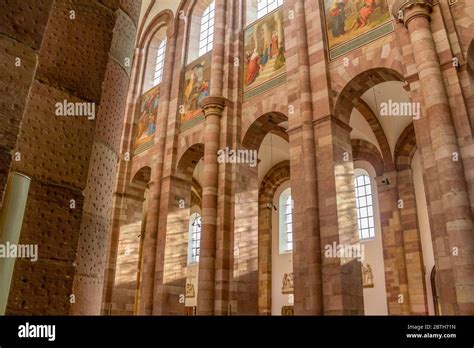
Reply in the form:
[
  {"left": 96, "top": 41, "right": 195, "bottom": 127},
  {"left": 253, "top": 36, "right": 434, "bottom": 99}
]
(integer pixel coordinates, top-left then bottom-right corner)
[{"left": 284, "top": 0, "right": 324, "bottom": 315}]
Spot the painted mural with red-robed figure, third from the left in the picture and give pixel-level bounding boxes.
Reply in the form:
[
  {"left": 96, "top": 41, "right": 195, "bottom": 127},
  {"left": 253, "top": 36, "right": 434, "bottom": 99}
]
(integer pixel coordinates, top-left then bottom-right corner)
[{"left": 243, "top": 9, "right": 286, "bottom": 99}]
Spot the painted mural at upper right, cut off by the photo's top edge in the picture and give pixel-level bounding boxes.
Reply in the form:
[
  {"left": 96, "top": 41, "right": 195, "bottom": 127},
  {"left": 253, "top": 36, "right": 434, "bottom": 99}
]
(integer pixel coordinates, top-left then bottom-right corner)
[{"left": 324, "top": 0, "right": 394, "bottom": 58}]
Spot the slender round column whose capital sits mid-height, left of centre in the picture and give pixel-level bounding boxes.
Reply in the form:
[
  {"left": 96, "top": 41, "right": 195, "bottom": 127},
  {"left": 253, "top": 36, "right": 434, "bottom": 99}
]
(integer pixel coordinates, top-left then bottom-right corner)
[{"left": 197, "top": 97, "right": 225, "bottom": 315}]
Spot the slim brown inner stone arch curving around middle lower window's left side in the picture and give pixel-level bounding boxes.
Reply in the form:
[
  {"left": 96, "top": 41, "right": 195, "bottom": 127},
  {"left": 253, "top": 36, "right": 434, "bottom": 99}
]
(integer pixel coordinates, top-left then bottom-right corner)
[{"left": 258, "top": 161, "right": 290, "bottom": 315}]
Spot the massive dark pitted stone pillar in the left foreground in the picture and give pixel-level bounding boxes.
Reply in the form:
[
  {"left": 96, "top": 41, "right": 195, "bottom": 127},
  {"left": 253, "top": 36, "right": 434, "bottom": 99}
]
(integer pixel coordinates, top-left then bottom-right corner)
[{"left": 2, "top": 0, "right": 139, "bottom": 314}]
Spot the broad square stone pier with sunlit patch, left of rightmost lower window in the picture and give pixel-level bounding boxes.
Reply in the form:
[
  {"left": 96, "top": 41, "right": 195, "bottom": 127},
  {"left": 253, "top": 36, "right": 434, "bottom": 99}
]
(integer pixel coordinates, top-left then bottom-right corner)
[{"left": 316, "top": 116, "right": 364, "bottom": 315}]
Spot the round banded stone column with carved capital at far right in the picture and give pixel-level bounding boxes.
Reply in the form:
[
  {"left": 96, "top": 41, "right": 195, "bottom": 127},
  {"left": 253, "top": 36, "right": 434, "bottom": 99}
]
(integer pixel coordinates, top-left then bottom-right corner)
[{"left": 392, "top": 0, "right": 474, "bottom": 314}]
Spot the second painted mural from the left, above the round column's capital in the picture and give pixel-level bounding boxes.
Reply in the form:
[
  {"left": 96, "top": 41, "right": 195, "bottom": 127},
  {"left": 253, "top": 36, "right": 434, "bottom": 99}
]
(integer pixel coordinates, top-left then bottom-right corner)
[{"left": 181, "top": 52, "right": 211, "bottom": 129}]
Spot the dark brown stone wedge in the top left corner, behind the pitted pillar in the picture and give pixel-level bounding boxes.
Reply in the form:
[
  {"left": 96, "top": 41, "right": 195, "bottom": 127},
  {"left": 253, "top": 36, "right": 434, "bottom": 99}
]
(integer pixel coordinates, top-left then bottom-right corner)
[{"left": 0, "top": 0, "right": 52, "bottom": 207}]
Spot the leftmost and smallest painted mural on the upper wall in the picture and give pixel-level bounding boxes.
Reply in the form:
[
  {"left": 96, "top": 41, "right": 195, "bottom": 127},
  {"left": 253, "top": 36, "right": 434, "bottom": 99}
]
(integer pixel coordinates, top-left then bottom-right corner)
[{"left": 134, "top": 85, "right": 160, "bottom": 154}]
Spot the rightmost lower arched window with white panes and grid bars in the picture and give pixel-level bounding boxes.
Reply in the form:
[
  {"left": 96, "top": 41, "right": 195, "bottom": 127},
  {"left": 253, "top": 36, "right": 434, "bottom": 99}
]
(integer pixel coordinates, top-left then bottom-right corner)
[{"left": 355, "top": 173, "right": 375, "bottom": 240}]
